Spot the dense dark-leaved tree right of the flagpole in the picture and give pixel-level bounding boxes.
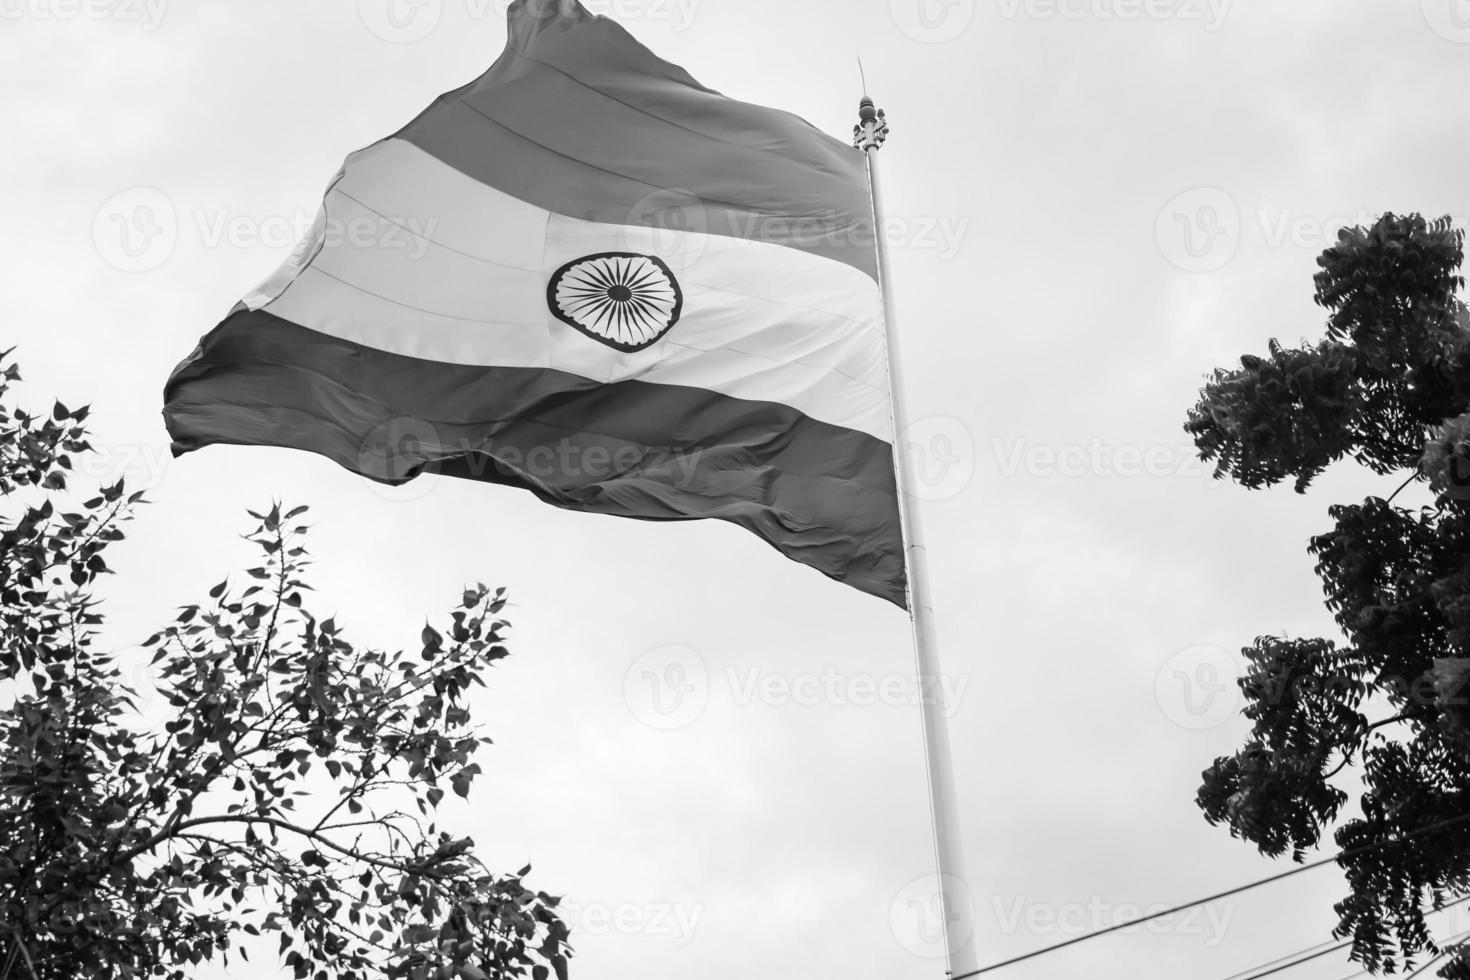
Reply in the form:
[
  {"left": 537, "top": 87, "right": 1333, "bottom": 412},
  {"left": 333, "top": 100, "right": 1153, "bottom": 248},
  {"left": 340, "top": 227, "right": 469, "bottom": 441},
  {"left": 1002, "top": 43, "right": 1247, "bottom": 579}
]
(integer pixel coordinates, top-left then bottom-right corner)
[{"left": 1185, "top": 215, "right": 1470, "bottom": 980}]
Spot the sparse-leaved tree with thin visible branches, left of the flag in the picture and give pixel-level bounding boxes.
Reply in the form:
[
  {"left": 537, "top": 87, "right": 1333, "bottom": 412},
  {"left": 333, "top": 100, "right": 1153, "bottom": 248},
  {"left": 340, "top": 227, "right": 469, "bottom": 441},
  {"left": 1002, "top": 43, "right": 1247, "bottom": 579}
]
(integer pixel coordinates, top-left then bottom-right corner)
[{"left": 0, "top": 354, "right": 570, "bottom": 980}]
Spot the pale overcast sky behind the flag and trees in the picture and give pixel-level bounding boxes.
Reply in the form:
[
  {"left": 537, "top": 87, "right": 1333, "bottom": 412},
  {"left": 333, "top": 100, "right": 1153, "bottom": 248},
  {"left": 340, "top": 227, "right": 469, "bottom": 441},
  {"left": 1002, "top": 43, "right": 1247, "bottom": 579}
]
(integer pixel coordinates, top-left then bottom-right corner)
[{"left": 0, "top": 0, "right": 1470, "bottom": 980}]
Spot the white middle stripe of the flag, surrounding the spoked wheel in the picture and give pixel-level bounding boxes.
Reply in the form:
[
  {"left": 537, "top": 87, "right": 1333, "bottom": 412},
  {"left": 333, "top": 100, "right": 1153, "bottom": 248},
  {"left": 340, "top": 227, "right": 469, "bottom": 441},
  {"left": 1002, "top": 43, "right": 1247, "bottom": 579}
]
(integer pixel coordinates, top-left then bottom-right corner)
[{"left": 247, "top": 140, "right": 892, "bottom": 441}]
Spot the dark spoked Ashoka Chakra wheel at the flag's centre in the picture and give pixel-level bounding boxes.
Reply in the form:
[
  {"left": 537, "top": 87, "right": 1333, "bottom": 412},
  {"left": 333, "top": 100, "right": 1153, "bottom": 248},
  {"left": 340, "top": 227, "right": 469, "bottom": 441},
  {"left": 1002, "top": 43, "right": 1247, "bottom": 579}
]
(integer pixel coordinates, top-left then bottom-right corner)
[{"left": 547, "top": 251, "right": 684, "bottom": 353}]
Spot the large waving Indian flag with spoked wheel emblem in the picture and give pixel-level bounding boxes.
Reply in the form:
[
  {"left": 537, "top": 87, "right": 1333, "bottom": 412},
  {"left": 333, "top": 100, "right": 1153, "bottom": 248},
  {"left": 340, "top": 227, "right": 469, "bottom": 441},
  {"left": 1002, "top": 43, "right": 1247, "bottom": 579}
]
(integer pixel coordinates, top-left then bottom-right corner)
[{"left": 165, "top": 0, "right": 906, "bottom": 604}]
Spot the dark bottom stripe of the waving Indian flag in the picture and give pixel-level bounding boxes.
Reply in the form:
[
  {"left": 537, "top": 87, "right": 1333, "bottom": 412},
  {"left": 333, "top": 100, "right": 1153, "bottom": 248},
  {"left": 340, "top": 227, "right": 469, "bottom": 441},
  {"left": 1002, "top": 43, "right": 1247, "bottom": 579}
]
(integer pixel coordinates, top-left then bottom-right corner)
[{"left": 165, "top": 309, "right": 906, "bottom": 605}]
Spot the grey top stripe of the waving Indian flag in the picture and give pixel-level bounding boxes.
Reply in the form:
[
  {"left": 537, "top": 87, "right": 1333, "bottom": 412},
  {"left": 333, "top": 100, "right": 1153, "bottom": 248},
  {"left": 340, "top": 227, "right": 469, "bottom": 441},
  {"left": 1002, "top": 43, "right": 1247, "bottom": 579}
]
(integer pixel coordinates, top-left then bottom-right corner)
[{"left": 397, "top": 0, "right": 878, "bottom": 279}]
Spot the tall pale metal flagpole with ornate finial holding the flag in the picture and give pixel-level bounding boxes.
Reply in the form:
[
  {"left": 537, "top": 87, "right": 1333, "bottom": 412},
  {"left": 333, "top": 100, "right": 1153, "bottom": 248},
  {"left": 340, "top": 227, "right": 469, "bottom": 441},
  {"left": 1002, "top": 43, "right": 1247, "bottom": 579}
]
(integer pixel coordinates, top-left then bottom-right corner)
[{"left": 853, "top": 94, "right": 979, "bottom": 980}]
